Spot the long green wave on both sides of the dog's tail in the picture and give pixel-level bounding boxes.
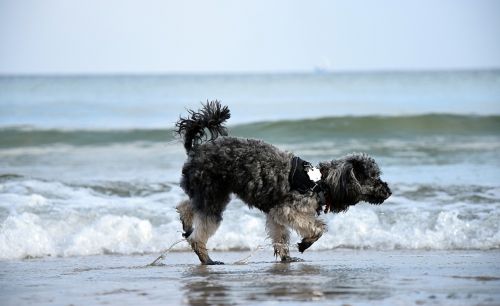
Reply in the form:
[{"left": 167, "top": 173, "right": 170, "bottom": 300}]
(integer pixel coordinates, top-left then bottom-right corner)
[{"left": 0, "top": 114, "right": 500, "bottom": 148}]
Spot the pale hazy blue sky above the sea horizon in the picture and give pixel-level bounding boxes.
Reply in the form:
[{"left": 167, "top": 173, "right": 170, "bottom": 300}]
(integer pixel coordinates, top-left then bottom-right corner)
[{"left": 0, "top": 0, "right": 500, "bottom": 74}]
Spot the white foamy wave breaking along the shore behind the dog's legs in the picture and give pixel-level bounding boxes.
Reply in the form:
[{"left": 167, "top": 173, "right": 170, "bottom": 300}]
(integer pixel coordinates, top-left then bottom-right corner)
[{"left": 0, "top": 174, "right": 500, "bottom": 260}]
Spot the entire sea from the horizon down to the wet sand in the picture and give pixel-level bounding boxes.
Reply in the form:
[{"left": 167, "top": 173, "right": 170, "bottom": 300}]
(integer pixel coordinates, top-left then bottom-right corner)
[{"left": 0, "top": 71, "right": 500, "bottom": 259}]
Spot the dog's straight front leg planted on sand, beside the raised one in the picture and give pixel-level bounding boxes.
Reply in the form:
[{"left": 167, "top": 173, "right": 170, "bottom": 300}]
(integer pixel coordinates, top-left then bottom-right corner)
[{"left": 266, "top": 214, "right": 302, "bottom": 262}]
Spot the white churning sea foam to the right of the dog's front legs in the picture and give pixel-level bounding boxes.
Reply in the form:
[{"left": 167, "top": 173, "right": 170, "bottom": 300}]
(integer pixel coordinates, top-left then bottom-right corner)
[{"left": 313, "top": 207, "right": 500, "bottom": 249}]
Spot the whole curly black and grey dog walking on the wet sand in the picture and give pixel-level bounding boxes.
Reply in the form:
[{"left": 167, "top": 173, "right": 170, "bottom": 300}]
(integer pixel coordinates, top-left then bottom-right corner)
[{"left": 175, "top": 101, "right": 391, "bottom": 265}]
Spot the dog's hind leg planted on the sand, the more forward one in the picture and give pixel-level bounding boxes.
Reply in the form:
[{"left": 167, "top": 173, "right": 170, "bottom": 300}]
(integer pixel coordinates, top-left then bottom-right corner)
[{"left": 187, "top": 212, "right": 224, "bottom": 265}]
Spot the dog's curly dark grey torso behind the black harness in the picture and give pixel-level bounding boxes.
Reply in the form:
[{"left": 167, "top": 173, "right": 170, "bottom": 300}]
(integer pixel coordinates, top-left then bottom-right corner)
[{"left": 181, "top": 137, "right": 292, "bottom": 215}]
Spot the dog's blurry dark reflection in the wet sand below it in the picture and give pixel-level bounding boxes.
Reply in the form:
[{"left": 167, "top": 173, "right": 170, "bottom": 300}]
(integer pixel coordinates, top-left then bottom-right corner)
[{"left": 183, "top": 263, "right": 390, "bottom": 305}]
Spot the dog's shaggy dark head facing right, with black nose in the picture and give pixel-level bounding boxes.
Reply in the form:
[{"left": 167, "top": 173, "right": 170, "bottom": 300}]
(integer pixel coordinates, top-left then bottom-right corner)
[{"left": 320, "top": 153, "right": 391, "bottom": 212}]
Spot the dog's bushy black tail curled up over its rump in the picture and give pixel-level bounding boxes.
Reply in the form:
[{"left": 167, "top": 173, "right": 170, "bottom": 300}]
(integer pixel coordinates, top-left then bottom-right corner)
[{"left": 175, "top": 100, "right": 231, "bottom": 152}]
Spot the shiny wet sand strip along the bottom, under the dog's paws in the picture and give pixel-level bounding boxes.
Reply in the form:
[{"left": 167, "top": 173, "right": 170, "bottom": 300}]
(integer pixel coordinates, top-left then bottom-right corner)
[{"left": 0, "top": 249, "right": 500, "bottom": 306}]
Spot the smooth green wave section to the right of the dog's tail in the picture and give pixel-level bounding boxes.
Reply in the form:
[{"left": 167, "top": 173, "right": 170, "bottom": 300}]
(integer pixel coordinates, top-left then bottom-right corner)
[{"left": 232, "top": 114, "right": 500, "bottom": 142}]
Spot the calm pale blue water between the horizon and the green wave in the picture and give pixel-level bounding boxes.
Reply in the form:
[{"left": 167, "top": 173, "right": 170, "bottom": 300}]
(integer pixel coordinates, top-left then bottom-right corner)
[{"left": 0, "top": 71, "right": 500, "bottom": 129}]
